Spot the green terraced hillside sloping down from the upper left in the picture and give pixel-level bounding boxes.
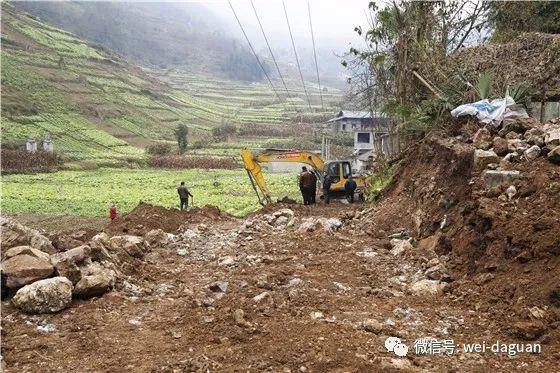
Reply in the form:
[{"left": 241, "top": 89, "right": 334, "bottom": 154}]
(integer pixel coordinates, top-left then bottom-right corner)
[{"left": 2, "top": 3, "right": 342, "bottom": 162}]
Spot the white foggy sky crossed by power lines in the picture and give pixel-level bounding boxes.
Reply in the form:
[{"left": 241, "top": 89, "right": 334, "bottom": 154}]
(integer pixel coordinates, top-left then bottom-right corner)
[{"left": 201, "top": 0, "right": 368, "bottom": 88}]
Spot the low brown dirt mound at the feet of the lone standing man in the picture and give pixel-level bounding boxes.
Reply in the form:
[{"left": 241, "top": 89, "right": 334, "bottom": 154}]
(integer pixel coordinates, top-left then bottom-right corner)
[{"left": 105, "top": 202, "right": 235, "bottom": 235}]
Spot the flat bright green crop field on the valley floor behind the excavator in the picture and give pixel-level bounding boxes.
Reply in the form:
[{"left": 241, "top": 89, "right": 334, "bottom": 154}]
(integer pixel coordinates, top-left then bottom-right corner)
[{"left": 2, "top": 168, "right": 299, "bottom": 216}]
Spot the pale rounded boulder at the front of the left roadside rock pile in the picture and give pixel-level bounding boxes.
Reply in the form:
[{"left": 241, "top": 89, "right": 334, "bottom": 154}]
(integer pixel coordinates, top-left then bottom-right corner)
[{"left": 12, "top": 277, "right": 73, "bottom": 314}]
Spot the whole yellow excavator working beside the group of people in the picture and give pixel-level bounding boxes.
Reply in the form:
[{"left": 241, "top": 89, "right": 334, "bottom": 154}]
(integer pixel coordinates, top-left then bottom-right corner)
[{"left": 241, "top": 148, "right": 366, "bottom": 205}]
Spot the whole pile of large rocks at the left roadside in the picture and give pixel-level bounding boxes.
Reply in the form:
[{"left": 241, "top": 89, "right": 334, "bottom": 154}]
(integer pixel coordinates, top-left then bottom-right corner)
[{"left": 2, "top": 219, "right": 160, "bottom": 313}]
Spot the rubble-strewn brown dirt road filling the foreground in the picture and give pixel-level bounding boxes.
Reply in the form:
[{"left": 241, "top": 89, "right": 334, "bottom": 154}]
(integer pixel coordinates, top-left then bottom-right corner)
[{"left": 2, "top": 205, "right": 560, "bottom": 372}]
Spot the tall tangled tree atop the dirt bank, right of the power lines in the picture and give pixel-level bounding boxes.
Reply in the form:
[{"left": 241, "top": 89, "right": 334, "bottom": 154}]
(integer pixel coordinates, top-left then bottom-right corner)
[{"left": 343, "top": 0, "right": 490, "bottom": 141}]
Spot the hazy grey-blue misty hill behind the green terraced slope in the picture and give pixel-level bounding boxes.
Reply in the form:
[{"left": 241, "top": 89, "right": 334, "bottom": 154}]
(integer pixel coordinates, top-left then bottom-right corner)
[{"left": 13, "top": 1, "right": 263, "bottom": 81}]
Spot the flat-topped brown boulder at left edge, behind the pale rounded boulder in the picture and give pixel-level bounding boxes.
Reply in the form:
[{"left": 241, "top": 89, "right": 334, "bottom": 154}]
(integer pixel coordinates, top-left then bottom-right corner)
[{"left": 2, "top": 254, "right": 54, "bottom": 289}]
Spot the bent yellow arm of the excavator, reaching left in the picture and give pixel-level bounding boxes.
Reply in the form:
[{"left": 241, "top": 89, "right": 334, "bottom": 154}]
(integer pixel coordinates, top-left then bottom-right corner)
[{"left": 241, "top": 148, "right": 325, "bottom": 204}]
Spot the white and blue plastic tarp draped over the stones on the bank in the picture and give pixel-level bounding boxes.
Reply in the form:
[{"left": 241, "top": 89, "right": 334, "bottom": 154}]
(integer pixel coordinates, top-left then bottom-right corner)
[{"left": 451, "top": 96, "right": 529, "bottom": 127}]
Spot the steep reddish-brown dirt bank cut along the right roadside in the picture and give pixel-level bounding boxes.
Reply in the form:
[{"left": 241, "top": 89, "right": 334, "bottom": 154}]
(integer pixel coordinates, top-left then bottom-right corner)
[{"left": 359, "top": 117, "right": 560, "bottom": 316}]
